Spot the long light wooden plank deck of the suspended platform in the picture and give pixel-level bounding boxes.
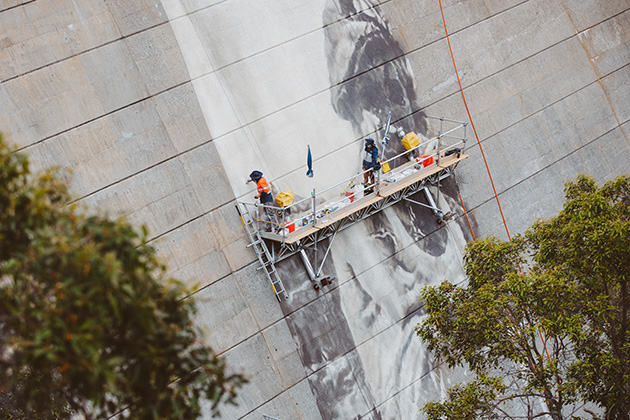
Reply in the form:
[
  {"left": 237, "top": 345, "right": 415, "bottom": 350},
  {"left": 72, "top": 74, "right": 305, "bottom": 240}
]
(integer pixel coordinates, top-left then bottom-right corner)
[{"left": 261, "top": 154, "right": 468, "bottom": 244}]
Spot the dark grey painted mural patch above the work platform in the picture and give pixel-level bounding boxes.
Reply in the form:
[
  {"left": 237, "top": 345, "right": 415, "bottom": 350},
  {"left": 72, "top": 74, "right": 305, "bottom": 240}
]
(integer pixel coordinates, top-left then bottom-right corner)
[{"left": 323, "top": 0, "right": 427, "bottom": 157}]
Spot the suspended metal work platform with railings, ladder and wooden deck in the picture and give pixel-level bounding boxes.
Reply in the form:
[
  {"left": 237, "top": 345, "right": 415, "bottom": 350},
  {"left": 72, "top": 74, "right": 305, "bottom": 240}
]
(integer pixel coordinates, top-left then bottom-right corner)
[{"left": 236, "top": 117, "right": 468, "bottom": 300}]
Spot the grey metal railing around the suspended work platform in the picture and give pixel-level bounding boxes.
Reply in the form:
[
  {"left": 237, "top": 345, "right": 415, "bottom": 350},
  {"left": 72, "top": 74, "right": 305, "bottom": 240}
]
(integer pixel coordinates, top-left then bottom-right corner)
[{"left": 239, "top": 117, "right": 468, "bottom": 238}]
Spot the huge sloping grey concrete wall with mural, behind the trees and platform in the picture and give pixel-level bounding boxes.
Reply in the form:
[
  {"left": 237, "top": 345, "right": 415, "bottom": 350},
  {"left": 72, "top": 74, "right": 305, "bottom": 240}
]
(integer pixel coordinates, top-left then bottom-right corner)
[{"left": 0, "top": 0, "right": 630, "bottom": 420}]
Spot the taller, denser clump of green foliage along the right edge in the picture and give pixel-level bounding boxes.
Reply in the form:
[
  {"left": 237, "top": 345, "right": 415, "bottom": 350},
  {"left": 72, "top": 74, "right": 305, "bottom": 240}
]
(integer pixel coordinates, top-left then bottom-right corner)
[{"left": 529, "top": 176, "right": 630, "bottom": 419}]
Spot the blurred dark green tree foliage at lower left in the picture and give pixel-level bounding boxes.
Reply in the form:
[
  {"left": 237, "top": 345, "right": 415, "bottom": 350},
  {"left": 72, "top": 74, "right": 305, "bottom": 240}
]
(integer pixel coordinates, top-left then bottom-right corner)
[{"left": 0, "top": 138, "right": 244, "bottom": 419}]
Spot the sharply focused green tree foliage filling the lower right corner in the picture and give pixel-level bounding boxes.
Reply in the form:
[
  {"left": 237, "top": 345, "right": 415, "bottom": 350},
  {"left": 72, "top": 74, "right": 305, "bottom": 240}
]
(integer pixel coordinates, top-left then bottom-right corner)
[{"left": 416, "top": 176, "right": 630, "bottom": 420}]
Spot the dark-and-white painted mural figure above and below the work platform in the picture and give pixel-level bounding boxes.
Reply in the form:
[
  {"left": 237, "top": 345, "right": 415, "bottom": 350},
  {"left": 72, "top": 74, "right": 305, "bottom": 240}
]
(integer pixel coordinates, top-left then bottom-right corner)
[{"left": 283, "top": 0, "right": 472, "bottom": 419}]
